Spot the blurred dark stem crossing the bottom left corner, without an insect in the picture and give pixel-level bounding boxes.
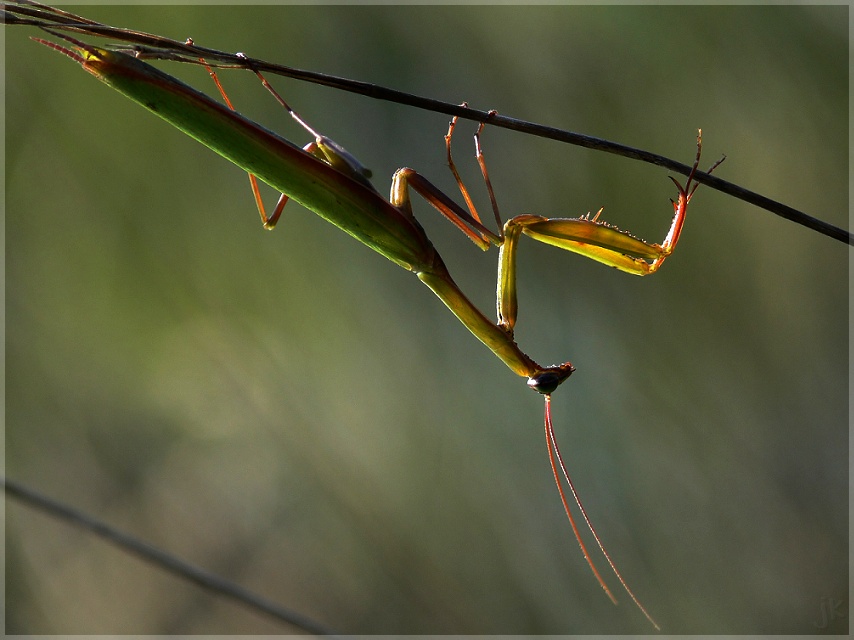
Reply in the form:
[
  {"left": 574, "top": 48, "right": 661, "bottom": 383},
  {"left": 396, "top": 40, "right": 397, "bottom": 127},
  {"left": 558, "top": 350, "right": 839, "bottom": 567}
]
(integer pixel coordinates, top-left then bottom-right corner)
[{"left": 0, "top": 478, "right": 332, "bottom": 636}]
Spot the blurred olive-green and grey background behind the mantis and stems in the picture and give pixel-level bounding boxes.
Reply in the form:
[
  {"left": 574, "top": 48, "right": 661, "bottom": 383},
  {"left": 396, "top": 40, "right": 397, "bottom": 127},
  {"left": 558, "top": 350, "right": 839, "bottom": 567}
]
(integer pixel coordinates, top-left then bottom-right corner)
[{"left": 5, "top": 6, "right": 849, "bottom": 634}]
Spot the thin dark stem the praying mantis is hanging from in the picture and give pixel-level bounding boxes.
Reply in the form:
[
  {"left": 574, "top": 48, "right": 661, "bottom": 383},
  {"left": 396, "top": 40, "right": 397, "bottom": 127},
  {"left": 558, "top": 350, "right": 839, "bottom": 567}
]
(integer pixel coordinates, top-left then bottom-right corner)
[{"left": 0, "top": 0, "right": 854, "bottom": 245}]
